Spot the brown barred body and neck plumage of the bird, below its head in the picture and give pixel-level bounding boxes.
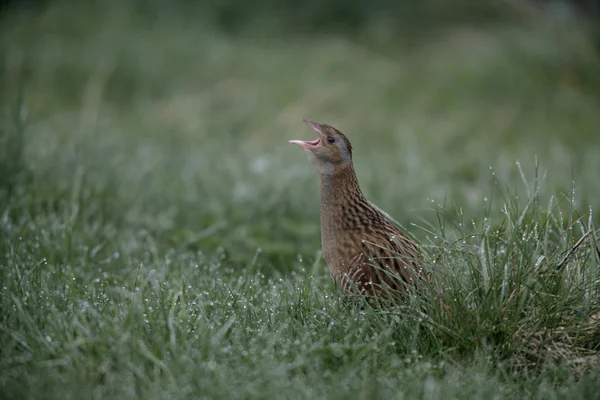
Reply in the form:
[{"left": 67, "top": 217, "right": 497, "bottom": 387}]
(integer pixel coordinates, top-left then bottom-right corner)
[{"left": 320, "top": 163, "right": 422, "bottom": 295}]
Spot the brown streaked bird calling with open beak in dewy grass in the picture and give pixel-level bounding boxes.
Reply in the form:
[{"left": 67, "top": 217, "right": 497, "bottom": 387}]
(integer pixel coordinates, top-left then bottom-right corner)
[{"left": 289, "top": 118, "right": 423, "bottom": 299}]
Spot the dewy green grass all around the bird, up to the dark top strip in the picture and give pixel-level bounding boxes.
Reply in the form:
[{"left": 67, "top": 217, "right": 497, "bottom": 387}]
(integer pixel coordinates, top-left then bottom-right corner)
[{"left": 0, "top": 3, "right": 600, "bottom": 399}]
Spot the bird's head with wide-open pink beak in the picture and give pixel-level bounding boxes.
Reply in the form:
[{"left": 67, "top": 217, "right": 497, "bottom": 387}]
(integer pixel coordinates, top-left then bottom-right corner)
[{"left": 290, "top": 118, "right": 352, "bottom": 172}]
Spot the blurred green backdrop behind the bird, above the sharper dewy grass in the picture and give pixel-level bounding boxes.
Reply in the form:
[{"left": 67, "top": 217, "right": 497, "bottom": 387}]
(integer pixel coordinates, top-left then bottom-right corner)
[{"left": 1, "top": 0, "right": 600, "bottom": 262}]
